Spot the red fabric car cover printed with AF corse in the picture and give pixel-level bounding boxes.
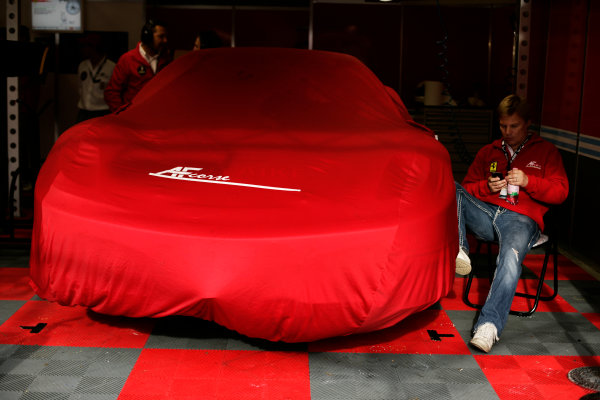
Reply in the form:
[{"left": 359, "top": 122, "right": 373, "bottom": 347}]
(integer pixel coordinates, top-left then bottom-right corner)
[{"left": 31, "top": 48, "right": 458, "bottom": 342}]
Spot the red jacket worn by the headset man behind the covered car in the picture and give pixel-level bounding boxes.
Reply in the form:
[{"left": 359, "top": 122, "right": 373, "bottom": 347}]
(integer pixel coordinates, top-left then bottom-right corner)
[{"left": 104, "top": 42, "right": 171, "bottom": 112}]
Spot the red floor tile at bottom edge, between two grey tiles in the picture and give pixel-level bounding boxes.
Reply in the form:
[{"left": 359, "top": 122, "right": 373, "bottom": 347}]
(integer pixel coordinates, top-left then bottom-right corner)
[{"left": 119, "top": 349, "right": 310, "bottom": 400}]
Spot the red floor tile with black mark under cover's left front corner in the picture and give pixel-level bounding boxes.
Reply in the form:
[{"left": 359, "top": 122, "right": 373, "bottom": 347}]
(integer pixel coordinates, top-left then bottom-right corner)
[{"left": 0, "top": 301, "right": 154, "bottom": 348}]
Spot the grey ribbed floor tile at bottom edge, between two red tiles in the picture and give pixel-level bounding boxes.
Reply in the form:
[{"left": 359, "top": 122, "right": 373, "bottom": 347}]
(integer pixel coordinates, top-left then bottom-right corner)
[{"left": 310, "top": 353, "right": 495, "bottom": 400}]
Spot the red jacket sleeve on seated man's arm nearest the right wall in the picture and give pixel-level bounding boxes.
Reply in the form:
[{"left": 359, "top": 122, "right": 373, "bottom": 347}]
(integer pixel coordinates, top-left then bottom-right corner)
[{"left": 524, "top": 144, "right": 569, "bottom": 204}]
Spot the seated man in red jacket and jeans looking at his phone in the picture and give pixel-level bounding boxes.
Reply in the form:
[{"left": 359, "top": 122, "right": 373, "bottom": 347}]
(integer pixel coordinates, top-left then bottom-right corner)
[{"left": 456, "top": 95, "right": 569, "bottom": 352}]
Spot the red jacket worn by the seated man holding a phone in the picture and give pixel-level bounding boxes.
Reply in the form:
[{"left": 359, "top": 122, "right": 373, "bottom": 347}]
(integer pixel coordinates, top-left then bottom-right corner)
[{"left": 462, "top": 134, "right": 569, "bottom": 230}]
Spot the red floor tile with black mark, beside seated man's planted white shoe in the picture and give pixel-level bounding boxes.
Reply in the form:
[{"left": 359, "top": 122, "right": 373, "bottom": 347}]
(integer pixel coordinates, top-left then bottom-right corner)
[{"left": 308, "top": 310, "right": 470, "bottom": 354}]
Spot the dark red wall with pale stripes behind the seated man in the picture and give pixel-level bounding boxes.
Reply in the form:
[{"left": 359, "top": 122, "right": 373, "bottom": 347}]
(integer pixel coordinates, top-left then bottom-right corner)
[{"left": 541, "top": 0, "right": 600, "bottom": 263}]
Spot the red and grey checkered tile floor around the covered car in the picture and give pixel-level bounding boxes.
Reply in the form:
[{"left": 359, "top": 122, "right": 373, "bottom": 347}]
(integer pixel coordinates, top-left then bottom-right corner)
[{"left": 0, "top": 249, "right": 600, "bottom": 400}]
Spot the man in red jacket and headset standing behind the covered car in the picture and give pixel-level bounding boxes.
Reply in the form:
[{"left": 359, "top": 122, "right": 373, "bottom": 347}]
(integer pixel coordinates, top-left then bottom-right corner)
[{"left": 104, "top": 20, "right": 171, "bottom": 112}]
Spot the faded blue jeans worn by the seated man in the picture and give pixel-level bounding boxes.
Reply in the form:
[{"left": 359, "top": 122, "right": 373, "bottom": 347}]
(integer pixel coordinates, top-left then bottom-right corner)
[{"left": 456, "top": 183, "right": 540, "bottom": 336}]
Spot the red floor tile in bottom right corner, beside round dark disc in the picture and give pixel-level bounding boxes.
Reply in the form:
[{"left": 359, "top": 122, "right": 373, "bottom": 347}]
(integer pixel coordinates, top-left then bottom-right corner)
[{"left": 474, "top": 355, "right": 600, "bottom": 400}]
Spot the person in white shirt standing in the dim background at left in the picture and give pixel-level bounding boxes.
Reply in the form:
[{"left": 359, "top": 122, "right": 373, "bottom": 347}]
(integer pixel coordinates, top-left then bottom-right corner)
[{"left": 77, "top": 33, "right": 115, "bottom": 122}]
